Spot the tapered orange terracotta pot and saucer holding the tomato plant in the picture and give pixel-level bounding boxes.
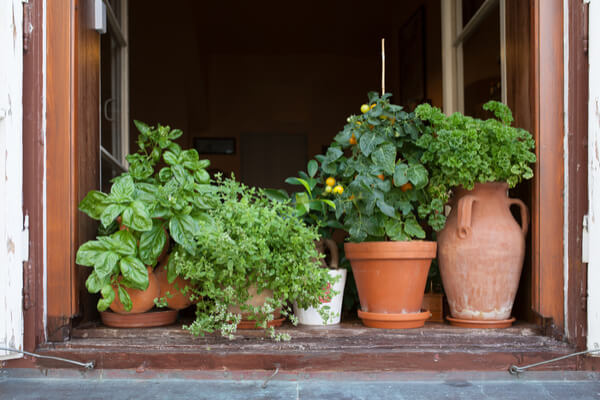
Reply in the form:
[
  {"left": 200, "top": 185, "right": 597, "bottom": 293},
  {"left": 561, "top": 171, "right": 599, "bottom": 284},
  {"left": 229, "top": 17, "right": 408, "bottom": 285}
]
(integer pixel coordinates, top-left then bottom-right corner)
[{"left": 344, "top": 240, "right": 436, "bottom": 328}]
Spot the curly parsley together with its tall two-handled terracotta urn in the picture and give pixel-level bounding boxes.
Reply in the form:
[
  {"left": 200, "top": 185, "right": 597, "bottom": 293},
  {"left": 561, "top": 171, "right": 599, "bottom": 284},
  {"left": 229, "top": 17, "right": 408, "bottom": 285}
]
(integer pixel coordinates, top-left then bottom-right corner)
[{"left": 416, "top": 101, "right": 536, "bottom": 328}]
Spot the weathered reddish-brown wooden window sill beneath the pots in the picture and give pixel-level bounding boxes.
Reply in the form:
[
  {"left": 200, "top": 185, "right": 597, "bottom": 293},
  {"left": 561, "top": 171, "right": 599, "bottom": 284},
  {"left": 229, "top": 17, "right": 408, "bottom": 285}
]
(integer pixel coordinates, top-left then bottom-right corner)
[{"left": 38, "top": 321, "right": 577, "bottom": 372}]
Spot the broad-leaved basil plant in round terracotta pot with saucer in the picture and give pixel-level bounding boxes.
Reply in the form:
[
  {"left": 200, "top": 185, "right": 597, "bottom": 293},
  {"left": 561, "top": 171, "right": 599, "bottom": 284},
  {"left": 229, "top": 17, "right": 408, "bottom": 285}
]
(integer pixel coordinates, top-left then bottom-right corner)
[{"left": 76, "top": 121, "right": 210, "bottom": 325}]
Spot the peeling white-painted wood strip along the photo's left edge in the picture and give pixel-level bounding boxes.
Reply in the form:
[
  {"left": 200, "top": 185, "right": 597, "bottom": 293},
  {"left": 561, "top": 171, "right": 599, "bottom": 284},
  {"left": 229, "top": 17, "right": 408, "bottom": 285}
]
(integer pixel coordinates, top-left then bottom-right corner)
[{"left": 0, "top": 0, "right": 23, "bottom": 360}]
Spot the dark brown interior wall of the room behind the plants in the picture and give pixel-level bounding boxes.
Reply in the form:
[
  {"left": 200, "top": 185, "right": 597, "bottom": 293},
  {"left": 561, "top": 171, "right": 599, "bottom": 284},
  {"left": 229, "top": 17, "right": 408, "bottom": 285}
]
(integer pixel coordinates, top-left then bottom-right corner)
[{"left": 129, "top": 0, "right": 442, "bottom": 188}]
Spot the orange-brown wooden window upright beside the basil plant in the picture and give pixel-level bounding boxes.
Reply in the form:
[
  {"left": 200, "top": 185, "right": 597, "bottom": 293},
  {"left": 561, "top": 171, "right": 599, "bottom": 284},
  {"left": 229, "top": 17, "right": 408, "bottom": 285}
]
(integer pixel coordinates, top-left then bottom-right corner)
[{"left": 46, "top": 0, "right": 100, "bottom": 341}]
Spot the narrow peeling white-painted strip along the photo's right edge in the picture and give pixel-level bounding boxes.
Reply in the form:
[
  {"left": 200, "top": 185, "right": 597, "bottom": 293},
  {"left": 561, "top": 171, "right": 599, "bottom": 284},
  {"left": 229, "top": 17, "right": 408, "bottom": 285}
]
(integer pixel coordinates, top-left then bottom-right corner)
[{"left": 587, "top": 0, "right": 600, "bottom": 350}]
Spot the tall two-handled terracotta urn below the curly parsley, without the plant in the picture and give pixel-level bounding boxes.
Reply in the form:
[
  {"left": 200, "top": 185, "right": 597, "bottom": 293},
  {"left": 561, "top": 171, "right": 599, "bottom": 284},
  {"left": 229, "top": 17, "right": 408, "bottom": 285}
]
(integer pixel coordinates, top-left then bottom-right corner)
[{"left": 438, "top": 182, "right": 529, "bottom": 327}]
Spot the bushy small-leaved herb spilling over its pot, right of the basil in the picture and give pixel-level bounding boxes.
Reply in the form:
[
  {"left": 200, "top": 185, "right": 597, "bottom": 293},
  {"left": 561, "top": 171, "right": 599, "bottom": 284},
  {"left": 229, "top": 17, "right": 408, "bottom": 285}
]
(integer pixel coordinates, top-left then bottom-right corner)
[{"left": 168, "top": 177, "right": 330, "bottom": 339}]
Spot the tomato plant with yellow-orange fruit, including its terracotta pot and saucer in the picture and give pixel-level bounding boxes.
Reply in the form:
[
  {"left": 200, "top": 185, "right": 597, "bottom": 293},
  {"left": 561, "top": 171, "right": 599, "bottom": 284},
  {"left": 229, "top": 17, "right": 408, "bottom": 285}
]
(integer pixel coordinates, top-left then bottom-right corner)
[{"left": 318, "top": 93, "right": 445, "bottom": 328}]
